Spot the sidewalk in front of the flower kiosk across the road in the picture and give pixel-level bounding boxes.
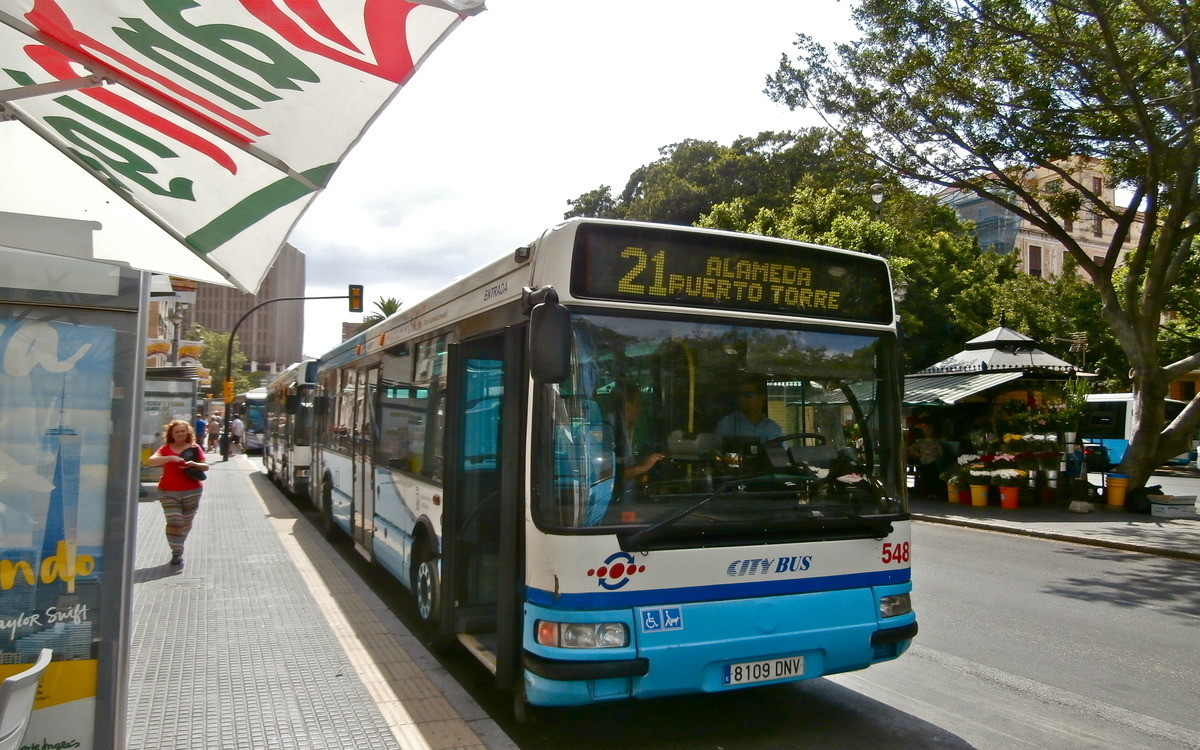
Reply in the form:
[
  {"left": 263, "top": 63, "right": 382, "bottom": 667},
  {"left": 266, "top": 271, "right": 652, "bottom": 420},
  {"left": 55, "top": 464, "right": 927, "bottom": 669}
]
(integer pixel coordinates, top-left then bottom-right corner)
[{"left": 908, "top": 473, "right": 1200, "bottom": 560}]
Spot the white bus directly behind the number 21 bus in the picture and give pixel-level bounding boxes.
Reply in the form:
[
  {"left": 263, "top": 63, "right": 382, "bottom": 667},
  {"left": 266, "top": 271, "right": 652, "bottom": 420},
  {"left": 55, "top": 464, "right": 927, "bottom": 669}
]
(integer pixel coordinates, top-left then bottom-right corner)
[{"left": 263, "top": 359, "right": 317, "bottom": 498}]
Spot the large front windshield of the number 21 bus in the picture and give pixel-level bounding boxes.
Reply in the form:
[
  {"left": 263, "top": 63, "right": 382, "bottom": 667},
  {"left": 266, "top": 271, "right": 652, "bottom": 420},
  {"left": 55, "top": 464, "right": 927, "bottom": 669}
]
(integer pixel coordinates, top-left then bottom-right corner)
[{"left": 535, "top": 314, "right": 906, "bottom": 548}]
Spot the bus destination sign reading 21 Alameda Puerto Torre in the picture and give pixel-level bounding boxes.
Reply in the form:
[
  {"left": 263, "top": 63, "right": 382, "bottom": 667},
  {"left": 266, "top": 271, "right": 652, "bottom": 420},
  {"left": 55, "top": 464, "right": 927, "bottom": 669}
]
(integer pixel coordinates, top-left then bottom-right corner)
[{"left": 571, "top": 224, "right": 893, "bottom": 323}]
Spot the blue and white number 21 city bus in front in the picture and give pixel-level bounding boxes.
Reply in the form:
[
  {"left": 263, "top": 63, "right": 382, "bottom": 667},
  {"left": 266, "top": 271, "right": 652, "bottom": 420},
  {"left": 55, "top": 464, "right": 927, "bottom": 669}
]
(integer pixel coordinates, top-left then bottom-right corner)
[{"left": 312, "top": 220, "right": 917, "bottom": 716}]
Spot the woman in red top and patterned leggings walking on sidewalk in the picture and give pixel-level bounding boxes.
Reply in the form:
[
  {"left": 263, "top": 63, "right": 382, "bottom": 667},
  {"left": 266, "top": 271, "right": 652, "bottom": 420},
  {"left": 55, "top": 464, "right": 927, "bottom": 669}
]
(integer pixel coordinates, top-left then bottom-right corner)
[{"left": 148, "top": 419, "right": 209, "bottom": 565}]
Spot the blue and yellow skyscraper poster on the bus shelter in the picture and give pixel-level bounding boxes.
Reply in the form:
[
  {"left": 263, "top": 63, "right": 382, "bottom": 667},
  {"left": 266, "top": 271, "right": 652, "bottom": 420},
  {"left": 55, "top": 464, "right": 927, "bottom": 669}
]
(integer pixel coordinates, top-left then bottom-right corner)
[{"left": 0, "top": 305, "right": 119, "bottom": 749}]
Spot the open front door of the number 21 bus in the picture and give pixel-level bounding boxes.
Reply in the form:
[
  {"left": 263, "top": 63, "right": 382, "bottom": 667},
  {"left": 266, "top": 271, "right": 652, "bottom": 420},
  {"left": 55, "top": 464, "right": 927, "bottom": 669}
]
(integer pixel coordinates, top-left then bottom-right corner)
[{"left": 439, "top": 329, "right": 524, "bottom": 686}]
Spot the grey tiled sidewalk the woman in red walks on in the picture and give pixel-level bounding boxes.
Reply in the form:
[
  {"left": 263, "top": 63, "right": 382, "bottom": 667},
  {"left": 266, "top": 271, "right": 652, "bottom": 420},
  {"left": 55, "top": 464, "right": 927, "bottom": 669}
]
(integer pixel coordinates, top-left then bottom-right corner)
[{"left": 126, "top": 456, "right": 516, "bottom": 750}]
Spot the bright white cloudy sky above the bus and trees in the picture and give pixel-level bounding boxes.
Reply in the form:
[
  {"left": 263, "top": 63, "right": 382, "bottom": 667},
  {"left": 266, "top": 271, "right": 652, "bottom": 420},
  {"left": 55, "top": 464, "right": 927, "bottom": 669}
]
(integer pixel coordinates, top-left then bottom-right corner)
[{"left": 289, "top": 0, "right": 853, "bottom": 356}]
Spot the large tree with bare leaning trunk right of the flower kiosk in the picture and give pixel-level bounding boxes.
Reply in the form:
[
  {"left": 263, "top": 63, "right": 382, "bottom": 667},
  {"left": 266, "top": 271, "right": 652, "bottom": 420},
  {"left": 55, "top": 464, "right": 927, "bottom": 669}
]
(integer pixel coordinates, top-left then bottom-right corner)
[{"left": 767, "top": 0, "right": 1200, "bottom": 487}]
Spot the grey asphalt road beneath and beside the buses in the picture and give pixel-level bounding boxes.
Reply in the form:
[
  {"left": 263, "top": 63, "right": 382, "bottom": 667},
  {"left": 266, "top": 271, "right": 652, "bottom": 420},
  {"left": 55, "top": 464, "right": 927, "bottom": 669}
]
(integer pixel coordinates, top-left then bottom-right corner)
[{"left": 276, "top": 458, "right": 1200, "bottom": 750}]
